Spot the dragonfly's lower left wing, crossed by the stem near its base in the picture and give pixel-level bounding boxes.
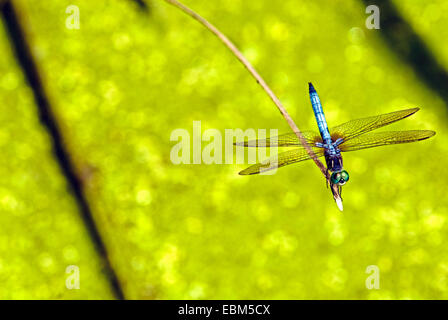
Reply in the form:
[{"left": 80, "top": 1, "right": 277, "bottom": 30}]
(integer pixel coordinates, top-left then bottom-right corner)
[{"left": 239, "top": 148, "right": 324, "bottom": 175}]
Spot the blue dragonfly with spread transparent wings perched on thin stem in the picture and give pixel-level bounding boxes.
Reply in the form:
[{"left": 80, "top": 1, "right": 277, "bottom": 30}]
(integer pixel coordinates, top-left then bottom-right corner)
[{"left": 235, "top": 82, "right": 436, "bottom": 190}]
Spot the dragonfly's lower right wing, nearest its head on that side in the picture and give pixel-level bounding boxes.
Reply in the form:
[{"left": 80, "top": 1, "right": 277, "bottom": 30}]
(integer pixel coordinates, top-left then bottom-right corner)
[{"left": 339, "top": 130, "right": 436, "bottom": 152}]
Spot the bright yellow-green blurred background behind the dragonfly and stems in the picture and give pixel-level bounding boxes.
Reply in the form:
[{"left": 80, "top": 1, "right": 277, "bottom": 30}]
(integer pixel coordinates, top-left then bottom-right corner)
[{"left": 0, "top": 0, "right": 448, "bottom": 299}]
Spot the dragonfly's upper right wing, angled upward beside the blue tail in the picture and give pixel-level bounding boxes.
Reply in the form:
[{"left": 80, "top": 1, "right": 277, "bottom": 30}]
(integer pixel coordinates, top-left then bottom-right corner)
[{"left": 330, "top": 108, "right": 420, "bottom": 141}]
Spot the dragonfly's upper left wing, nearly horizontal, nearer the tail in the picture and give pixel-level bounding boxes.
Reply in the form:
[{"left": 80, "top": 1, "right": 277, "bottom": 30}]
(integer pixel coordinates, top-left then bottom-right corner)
[{"left": 234, "top": 131, "right": 322, "bottom": 148}]
